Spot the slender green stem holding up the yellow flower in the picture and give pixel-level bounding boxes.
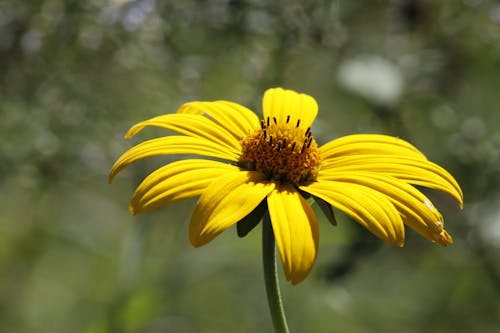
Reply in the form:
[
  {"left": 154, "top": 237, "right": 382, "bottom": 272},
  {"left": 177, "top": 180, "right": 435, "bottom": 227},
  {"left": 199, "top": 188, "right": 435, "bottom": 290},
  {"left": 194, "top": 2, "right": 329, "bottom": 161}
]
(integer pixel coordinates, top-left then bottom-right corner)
[{"left": 262, "top": 213, "right": 289, "bottom": 333}]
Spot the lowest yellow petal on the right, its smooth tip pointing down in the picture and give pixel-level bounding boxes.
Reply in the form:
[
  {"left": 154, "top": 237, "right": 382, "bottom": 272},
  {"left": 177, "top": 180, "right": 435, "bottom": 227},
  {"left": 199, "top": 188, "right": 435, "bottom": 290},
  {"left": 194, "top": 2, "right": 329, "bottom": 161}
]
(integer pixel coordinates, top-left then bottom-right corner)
[{"left": 300, "top": 180, "right": 404, "bottom": 246}]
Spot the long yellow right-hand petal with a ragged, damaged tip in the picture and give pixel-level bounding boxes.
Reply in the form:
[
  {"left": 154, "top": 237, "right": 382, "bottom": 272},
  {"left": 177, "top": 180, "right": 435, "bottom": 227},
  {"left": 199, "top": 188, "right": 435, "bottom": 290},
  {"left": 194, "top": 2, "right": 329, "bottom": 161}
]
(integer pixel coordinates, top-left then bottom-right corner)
[{"left": 318, "top": 171, "right": 454, "bottom": 245}]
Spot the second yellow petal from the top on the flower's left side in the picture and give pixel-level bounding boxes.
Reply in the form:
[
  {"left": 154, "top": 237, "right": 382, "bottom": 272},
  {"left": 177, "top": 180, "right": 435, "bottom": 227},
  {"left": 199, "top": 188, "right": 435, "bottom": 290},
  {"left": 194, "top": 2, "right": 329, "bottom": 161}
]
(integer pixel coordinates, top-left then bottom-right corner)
[{"left": 126, "top": 114, "right": 241, "bottom": 150}]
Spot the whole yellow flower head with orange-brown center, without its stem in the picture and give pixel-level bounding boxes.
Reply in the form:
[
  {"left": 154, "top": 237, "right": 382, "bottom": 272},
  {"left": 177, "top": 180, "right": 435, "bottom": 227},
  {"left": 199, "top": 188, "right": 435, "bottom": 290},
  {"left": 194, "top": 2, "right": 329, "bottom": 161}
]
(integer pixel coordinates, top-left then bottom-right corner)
[{"left": 110, "top": 88, "right": 463, "bottom": 284}]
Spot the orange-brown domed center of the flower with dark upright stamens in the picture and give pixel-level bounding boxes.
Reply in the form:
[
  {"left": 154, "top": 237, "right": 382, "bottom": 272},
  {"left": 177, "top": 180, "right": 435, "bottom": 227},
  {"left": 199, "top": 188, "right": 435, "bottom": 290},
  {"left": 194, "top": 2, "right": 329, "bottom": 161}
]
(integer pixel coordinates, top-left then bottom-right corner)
[{"left": 240, "top": 116, "right": 320, "bottom": 185}]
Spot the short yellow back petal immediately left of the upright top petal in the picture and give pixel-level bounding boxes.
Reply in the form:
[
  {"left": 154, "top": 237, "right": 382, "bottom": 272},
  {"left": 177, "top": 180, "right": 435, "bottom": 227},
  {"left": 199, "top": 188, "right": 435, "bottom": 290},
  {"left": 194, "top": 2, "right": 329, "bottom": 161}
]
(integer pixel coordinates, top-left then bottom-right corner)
[{"left": 177, "top": 101, "right": 260, "bottom": 139}]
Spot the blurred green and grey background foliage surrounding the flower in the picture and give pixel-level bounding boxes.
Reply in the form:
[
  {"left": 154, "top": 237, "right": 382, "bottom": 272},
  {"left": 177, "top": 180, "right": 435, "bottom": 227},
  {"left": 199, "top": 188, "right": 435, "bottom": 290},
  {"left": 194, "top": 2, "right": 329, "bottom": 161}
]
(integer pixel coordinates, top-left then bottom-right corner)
[{"left": 0, "top": 0, "right": 500, "bottom": 333}]
